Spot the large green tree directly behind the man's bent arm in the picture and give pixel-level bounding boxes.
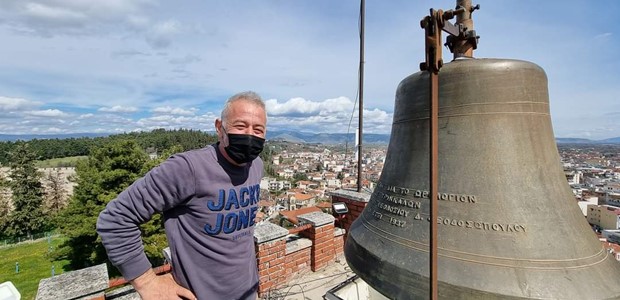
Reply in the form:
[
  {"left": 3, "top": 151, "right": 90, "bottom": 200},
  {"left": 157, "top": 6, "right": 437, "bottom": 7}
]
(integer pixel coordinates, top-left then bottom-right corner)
[{"left": 55, "top": 140, "right": 180, "bottom": 270}]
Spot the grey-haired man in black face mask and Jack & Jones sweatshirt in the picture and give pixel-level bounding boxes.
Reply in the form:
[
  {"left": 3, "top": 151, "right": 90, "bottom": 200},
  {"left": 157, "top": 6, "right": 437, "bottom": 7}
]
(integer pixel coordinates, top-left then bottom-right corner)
[{"left": 97, "top": 92, "right": 267, "bottom": 300}]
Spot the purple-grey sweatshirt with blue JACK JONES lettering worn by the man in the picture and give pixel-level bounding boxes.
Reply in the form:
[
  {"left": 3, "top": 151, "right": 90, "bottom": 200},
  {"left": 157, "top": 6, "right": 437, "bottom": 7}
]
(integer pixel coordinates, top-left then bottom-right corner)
[{"left": 97, "top": 144, "right": 263, "bottom": 300}]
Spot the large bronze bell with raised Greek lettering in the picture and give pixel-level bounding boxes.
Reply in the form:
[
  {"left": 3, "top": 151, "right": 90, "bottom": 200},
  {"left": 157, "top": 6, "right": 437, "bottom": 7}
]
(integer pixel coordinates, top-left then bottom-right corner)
[{"left": 345, "top": 58, "right": 620, "bottom": 299}]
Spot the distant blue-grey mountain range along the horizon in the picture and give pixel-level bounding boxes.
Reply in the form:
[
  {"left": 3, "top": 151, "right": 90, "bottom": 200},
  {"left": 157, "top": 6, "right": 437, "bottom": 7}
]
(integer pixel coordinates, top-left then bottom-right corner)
[{"left": 0, "top": 130, "right": 620, "bottom": 144}]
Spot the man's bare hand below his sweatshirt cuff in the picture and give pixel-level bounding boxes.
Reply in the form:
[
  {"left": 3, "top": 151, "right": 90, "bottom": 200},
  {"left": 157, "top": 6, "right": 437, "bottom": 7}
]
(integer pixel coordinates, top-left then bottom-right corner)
[{"left": 131, "top": 269, "right": 196, "bottom": 300}]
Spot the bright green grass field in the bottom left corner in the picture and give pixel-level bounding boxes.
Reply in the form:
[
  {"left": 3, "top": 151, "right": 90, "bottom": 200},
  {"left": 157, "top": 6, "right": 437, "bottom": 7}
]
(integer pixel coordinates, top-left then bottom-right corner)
[{"left": 0, "top": 236, "right": 69, "bottom": 300}]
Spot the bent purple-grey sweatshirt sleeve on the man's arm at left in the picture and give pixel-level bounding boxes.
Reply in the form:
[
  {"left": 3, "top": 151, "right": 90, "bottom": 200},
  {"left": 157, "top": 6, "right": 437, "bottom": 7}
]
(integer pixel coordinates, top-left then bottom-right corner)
[{"left": 97, "top": 155, "right": 195, "bottom": 280}]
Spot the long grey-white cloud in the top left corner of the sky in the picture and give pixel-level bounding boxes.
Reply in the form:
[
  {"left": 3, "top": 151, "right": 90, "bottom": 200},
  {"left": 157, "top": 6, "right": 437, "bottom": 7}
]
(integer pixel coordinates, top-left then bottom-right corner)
[{"left": 0, "top": 0, "right": 182, "bottom": 49}]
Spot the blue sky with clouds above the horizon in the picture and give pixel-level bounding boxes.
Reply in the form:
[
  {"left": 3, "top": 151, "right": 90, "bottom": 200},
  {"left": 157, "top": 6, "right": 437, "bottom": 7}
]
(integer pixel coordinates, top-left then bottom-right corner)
[{"left": 0, "top": 0, "right": 620, "bottom": 139}]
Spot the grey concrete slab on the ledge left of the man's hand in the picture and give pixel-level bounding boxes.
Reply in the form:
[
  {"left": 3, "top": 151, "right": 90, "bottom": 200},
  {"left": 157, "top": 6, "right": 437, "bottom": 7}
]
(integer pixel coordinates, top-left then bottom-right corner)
[{"left": 36, "top": 264, "right": 109, "bottom": 300}]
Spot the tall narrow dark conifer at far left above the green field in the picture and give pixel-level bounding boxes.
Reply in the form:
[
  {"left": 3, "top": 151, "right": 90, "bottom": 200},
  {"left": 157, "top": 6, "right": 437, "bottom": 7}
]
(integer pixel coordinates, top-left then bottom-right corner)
[{"left": 6, "top": 143, "right": 48, "bottom": 236}]
